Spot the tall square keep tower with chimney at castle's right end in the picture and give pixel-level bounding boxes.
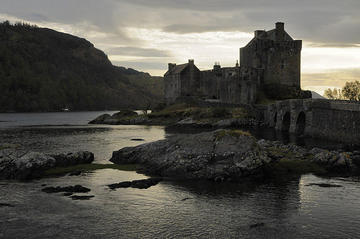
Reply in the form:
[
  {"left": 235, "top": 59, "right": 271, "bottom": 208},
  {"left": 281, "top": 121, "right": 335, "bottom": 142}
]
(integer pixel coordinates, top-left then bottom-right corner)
[{"left": 240, "top": 22, "right": 302, "bottom": 91}]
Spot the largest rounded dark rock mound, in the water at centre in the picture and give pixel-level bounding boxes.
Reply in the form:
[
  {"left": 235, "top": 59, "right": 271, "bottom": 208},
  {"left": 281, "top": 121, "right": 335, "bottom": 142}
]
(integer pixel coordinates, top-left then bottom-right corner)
[{"left": 110, "top": 130, "right": 272, "bottom": 181}]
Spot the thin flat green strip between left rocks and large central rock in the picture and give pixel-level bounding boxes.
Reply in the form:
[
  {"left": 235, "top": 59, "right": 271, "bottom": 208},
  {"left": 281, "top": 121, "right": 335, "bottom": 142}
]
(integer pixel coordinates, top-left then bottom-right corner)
[{"left": 44, "top": 163, "right": 137, "bottom": 176}]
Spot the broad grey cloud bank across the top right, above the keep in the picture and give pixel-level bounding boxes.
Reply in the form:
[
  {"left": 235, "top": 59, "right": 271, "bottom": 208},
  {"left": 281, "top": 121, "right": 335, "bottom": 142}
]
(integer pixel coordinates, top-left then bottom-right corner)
[{"left": 115, "top": 0, "right": 360, "bottom": 44}]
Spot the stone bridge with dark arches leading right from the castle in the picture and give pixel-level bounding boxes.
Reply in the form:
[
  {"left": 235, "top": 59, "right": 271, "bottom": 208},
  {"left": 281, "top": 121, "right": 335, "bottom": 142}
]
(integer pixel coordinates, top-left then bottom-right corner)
[{"left": 264, "top": 99, "right": 360, "bottom": 144}]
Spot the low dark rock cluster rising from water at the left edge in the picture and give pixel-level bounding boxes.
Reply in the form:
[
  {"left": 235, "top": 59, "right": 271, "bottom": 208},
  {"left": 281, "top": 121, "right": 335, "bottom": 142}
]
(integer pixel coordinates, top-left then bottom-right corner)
[{"left": 0, "top": 150, "right": 94, "bottom": 180}]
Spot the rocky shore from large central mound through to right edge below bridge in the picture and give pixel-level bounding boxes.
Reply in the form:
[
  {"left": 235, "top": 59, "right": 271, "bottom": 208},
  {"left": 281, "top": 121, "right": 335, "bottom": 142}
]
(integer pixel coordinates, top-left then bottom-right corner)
[{"left": 110, "top": 130, "right": 360, "bottom": 181}]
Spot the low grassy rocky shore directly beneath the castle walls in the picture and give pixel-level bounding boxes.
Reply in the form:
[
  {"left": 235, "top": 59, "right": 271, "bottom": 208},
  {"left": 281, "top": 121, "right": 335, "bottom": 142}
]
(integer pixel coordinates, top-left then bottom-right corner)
[{"left": 89, "top": 105, "right": 261, "bottom": 129}]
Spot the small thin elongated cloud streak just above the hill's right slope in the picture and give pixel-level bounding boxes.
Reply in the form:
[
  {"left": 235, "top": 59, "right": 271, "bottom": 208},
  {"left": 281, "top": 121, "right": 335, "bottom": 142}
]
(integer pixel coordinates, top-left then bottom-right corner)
[{"left": 106, "top": 47, "right": 171, "bottom": 57}]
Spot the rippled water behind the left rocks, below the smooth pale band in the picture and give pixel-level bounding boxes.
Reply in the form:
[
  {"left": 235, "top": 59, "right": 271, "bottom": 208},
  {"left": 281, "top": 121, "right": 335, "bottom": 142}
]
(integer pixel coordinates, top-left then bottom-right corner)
[{"left": 0, "top": 125, "right": 165, "bottom": 163}]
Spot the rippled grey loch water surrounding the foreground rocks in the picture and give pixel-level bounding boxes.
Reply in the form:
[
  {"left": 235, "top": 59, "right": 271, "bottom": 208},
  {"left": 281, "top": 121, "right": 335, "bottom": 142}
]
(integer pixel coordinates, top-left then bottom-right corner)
[{"left": 0, "top": 112, "right": 360, "bottom": 238}]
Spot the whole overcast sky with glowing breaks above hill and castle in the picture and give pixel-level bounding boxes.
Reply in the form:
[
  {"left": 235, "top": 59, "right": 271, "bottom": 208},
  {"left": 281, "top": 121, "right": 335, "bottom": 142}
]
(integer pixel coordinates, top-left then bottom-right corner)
[{"left": 0, "top": 0, "right": 360, "bottom": 94}]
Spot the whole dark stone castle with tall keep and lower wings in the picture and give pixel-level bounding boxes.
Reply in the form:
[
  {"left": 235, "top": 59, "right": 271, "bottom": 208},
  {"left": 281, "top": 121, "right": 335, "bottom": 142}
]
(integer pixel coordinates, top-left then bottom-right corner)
[{"left": 164, "top": 22, "right": 311, "bottom": 104}]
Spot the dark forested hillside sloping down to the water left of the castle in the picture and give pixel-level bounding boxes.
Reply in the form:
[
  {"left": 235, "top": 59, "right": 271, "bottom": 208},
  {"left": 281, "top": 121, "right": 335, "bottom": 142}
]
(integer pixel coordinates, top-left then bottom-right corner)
[{"left": 0, "top": 22, "right": 163, "bottom": 112}]
